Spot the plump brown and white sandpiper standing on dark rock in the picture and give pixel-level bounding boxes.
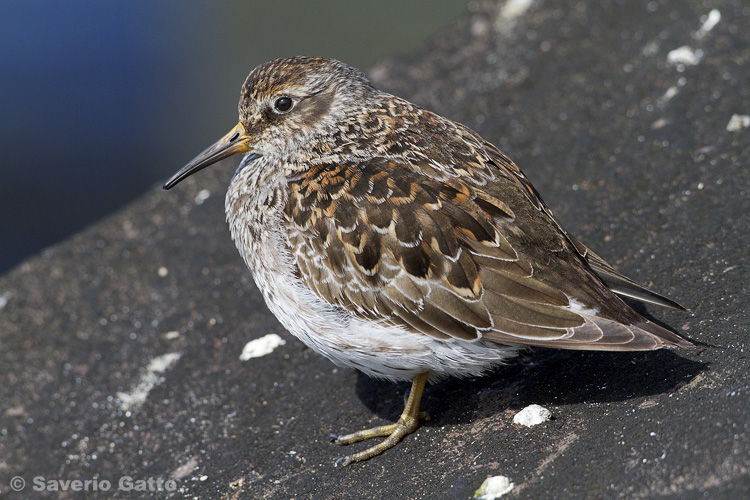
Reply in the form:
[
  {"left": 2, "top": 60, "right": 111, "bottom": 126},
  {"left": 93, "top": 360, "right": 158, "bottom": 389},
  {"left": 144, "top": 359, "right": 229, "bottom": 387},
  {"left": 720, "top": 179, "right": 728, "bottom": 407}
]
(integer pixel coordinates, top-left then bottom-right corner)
[{"left": 164, "top": 56, "right": 693, "bottom": 466}]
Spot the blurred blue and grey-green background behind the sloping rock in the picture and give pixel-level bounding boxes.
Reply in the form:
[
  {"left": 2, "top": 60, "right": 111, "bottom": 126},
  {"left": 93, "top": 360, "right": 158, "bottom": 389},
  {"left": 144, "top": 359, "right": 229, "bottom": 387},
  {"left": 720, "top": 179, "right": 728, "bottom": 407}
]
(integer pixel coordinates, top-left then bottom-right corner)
[{"left": 0, "top": 0, "right": 467, "bottom": 274}]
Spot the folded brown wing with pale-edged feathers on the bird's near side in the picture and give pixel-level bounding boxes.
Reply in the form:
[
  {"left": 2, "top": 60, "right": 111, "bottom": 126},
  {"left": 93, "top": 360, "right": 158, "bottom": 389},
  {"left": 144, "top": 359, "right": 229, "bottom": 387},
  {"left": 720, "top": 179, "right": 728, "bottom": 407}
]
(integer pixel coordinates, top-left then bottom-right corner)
[{"left": 285, "top": 112, "right": 689, "bottom": 350}]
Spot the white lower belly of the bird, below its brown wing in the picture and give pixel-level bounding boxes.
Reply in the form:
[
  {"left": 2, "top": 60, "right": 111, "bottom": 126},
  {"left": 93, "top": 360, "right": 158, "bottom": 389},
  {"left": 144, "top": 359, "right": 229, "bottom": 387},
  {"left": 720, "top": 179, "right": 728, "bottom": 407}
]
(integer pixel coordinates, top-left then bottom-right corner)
[{"left": 250, "top": 244, "right": 518, "bottom": 380}]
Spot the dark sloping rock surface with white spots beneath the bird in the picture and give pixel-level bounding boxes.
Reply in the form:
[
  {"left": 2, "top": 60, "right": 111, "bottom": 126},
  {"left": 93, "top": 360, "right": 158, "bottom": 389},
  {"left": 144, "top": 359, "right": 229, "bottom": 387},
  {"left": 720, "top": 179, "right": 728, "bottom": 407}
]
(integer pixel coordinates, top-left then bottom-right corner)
[{"left": 0, "top": 0, "right": 750, "bottom": 499}]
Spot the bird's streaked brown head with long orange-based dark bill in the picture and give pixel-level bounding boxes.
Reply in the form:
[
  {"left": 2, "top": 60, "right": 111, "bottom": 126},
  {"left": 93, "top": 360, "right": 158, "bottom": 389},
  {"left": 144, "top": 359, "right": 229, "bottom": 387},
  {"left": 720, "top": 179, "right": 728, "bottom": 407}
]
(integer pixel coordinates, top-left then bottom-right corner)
[{"left": 164, "top": 57, "right": 374, "bottom": 189}]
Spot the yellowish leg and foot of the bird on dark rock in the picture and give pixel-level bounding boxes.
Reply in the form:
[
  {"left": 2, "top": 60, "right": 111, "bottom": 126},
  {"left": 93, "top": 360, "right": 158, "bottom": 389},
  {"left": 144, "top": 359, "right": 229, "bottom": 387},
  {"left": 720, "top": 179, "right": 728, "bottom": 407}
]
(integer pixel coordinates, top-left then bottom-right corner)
[{"left": 333, "top": 372, "right": 427, "bottom": 466}]
